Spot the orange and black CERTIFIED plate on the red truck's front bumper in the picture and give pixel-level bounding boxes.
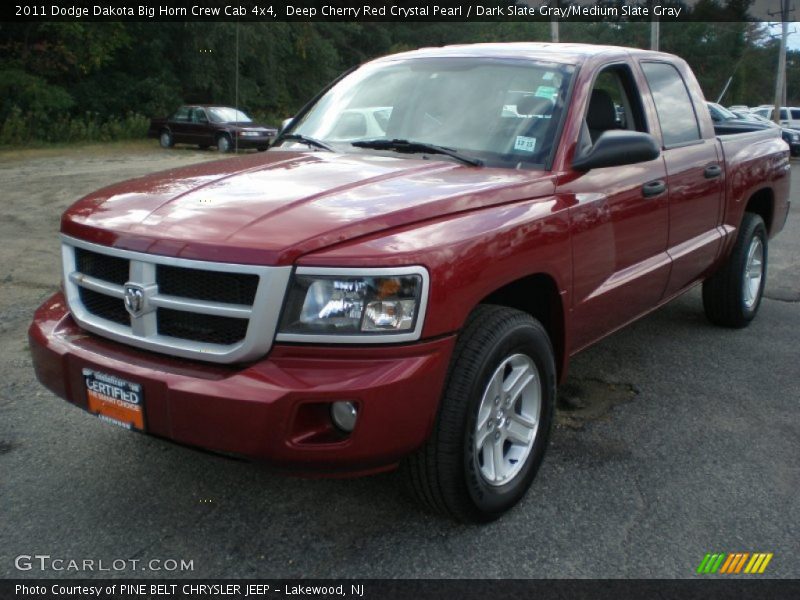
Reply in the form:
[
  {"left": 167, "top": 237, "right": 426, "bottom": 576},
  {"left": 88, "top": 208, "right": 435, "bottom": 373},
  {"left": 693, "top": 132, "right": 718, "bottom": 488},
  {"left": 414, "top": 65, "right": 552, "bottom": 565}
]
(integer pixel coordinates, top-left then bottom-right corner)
[{"left": 83, "top": 369, "right": 144, "bottom": 431}]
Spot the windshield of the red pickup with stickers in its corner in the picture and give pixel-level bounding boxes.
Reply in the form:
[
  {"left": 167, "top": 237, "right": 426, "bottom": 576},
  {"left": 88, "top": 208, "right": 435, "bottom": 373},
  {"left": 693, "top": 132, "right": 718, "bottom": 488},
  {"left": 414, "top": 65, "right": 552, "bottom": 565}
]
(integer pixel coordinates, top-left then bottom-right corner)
[{"left": 284, "top": 58, "right": 573, "bottom": 166}]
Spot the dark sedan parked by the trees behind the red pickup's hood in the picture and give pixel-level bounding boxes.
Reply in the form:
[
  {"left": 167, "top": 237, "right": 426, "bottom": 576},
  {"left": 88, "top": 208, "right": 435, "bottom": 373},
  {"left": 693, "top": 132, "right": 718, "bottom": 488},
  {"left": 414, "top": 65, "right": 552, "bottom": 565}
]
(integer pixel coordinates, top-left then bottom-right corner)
[{"left": 147, "top": 105, "right": 277, "bottom": 152}]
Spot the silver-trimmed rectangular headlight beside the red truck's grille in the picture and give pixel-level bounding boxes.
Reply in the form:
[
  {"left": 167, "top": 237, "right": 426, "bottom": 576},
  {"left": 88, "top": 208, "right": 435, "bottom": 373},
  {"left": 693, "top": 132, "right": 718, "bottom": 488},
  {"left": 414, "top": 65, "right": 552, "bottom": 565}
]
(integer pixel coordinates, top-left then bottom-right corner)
[{"left": 278, "top": 267, "right": 428, "bottom": 343}]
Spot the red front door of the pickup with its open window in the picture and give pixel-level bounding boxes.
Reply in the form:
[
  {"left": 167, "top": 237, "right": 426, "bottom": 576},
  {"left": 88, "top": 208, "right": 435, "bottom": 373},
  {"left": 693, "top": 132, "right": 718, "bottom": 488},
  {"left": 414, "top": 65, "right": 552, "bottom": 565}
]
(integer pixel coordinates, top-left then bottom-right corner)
[{"left": 558, "top": 64, "right": 670, "bottom": 352}]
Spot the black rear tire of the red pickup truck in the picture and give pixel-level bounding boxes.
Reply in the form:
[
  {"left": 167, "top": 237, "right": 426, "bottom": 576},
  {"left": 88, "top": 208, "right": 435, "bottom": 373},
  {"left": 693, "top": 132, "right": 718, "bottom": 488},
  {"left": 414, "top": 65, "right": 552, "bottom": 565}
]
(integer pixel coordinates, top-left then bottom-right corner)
[{"left": 703, "top": 212, "right": 768, "bottom": 328}]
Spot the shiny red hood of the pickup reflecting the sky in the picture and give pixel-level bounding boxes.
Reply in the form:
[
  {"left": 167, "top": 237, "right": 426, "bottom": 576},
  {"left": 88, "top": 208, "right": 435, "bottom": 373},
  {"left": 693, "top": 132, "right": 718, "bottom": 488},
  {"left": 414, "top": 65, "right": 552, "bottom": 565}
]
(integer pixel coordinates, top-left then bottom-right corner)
[{"left": 61, "top": 150, "right": 555, "bottom": 265}]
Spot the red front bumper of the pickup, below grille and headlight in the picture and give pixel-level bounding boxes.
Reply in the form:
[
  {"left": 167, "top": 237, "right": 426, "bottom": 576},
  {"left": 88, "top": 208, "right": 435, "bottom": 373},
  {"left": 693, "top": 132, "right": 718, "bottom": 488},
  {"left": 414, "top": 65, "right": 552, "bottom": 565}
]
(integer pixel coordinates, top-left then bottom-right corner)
[{"left": 28, "top": 293, "right": 455, "bottom": 474}]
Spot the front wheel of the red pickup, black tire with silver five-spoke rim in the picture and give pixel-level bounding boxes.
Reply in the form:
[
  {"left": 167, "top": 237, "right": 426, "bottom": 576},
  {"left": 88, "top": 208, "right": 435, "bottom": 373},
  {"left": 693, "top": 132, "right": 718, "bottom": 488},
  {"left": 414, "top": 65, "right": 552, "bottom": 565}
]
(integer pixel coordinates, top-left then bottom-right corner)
[{"left": 406, "top": 305, "right": 556, "bottom": 522}]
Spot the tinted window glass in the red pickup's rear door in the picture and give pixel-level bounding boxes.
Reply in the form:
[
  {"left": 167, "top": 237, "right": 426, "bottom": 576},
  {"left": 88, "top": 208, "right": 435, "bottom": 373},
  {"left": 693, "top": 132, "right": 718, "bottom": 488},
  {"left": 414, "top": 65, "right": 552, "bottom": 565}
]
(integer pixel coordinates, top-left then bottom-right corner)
[{"left": 642, "top": 62, "right": 700, "bottom": 148}]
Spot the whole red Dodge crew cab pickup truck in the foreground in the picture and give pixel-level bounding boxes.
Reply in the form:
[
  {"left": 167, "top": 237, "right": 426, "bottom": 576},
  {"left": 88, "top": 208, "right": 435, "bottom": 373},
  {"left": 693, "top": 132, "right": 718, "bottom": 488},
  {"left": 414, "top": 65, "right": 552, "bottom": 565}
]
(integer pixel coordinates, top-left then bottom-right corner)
[{"left": 30, "top": 43, "right": 790, "bottom": 521}]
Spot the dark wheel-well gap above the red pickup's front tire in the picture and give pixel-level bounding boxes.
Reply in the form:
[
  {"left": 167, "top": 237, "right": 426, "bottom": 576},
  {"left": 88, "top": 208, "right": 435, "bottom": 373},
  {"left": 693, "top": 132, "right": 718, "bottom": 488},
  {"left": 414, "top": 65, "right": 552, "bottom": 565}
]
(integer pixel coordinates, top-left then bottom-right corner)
[{"left": 478, "top": 273, "right": 567, "bottom": 380}]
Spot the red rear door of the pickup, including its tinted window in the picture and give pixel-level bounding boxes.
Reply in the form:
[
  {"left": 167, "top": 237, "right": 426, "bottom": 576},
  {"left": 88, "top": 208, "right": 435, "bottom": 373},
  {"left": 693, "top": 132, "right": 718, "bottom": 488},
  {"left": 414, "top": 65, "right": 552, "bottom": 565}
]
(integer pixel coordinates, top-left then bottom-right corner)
[{"left": 641, "top": 61, "right": 725, "bottom": 296}]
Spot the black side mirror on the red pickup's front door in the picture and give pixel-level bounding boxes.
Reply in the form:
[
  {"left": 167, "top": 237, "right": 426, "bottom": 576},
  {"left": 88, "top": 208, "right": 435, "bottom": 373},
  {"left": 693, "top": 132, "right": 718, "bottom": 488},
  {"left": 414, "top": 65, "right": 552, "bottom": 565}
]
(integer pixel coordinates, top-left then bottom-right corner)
[{"left": 572, "top": 129, "right": 661, "bottom": 171}]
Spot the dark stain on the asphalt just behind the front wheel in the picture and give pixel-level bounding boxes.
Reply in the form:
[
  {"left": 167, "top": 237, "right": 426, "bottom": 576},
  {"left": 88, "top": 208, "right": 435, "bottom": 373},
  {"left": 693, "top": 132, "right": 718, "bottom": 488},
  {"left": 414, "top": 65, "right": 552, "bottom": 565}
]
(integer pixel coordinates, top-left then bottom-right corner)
[{"left": 556, "top": 379, "right": 639, "bottom": 430}]
